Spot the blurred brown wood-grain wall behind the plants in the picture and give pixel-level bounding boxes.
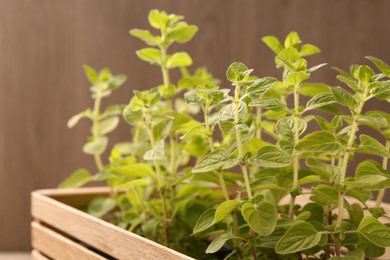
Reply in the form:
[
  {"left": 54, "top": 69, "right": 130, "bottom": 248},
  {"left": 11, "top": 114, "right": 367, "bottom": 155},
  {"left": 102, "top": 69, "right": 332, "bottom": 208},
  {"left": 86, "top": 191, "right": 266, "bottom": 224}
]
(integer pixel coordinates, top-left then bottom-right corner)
[{"left": 0, "top": 0, "right": 390, "bottom": 251}]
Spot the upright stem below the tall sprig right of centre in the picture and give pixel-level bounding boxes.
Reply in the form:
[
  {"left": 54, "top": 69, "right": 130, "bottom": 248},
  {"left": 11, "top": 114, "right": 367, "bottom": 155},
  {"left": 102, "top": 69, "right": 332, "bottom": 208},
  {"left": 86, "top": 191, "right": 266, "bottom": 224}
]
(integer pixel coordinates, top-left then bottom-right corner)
[{"left": 288, "top": 85, "right": 301, "bottom": 219}]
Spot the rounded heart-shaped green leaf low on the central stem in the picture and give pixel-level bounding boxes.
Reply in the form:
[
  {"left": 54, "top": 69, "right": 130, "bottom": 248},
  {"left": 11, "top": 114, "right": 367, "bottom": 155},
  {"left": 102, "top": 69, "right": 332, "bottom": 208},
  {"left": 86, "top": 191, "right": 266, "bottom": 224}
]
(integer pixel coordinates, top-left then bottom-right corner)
[{"left": 241, "top": 201, "right": 278, "bottom": 236}]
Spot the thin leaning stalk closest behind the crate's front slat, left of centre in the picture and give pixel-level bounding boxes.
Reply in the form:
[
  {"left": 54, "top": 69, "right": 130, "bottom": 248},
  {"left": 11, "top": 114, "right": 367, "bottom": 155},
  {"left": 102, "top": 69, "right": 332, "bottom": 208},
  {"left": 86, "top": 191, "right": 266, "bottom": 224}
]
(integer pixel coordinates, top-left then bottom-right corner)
[{"left": 144, "top": 110, "right": 169, "bottom": 246}]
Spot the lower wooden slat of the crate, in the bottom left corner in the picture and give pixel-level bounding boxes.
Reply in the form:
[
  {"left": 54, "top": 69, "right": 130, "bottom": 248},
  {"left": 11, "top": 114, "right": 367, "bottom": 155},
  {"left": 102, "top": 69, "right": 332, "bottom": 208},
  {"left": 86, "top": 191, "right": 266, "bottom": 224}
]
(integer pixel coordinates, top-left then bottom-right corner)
[{"left": 31, "top": 222, "right": 106, "bottom": 260}]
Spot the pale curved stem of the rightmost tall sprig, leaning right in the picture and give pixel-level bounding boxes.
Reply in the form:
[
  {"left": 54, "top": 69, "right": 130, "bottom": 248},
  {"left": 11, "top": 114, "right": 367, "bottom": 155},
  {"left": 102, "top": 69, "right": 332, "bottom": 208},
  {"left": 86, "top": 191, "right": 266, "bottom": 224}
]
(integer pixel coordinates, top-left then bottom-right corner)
[{"left": 336, "top": 86, "right": 368, "bottom": 227}]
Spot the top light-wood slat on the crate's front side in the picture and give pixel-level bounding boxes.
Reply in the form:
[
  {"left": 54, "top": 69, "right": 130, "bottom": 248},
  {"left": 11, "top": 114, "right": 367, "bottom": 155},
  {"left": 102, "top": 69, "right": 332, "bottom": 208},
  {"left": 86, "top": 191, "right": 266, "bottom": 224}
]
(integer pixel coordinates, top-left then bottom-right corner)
[{"left": 32, "top": 191, "right": 192, "bottom": 260}]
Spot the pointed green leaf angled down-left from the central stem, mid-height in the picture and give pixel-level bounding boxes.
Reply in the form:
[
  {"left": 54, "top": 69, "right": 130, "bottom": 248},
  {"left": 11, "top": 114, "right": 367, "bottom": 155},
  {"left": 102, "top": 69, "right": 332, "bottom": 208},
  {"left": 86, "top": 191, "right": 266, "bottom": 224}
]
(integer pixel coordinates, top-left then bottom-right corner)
[{"left": 192, "top": 149, "right": 229, "bottom": 173}]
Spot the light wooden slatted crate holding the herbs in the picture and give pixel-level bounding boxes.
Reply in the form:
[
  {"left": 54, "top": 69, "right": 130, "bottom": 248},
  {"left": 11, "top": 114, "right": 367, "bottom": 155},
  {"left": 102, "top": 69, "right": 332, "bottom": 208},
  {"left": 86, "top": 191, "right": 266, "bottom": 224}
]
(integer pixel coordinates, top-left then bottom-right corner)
[{"left": 31, "top": 187, "right": 390, "bottom": 260}]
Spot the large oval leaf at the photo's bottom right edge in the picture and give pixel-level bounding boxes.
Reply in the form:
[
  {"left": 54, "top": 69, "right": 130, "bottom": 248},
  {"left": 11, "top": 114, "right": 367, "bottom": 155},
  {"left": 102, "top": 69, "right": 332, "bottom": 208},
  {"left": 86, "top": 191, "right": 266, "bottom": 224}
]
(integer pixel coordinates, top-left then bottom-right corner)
[{"left": 358, "top": 216, "right": 390, "bottom": 247}]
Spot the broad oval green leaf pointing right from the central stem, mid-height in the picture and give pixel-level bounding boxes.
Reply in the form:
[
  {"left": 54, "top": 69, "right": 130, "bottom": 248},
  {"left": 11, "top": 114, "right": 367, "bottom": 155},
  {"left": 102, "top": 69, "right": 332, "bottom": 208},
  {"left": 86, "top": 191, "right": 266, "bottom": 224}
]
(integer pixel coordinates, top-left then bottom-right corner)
[{"left": 252, "top": 145, "right": 291, "bottom": 168}]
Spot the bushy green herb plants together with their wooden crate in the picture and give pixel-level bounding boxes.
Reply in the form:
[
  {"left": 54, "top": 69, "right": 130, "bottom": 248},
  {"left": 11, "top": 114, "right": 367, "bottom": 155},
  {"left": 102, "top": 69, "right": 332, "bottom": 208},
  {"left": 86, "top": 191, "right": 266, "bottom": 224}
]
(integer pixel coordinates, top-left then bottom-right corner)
[{"left": 32, "top": 10, "right": 390, "bottom": 259}]
